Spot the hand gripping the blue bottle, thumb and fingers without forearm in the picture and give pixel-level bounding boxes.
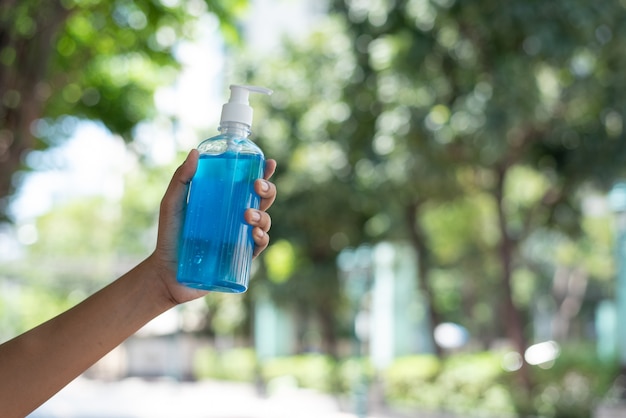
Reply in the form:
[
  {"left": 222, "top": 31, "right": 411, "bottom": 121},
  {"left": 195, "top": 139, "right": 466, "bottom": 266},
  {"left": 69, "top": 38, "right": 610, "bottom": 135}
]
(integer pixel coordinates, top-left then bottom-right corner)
[{"left": 149, "top": 149, "right": 276, "bottom": 304}]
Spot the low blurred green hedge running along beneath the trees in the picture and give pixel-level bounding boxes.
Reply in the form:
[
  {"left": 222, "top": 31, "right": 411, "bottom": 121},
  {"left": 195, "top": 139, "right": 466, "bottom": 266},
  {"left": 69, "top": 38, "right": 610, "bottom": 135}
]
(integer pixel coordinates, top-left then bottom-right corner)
[{"left": 196, "top": 344, "right": 618, "bottom": 418}]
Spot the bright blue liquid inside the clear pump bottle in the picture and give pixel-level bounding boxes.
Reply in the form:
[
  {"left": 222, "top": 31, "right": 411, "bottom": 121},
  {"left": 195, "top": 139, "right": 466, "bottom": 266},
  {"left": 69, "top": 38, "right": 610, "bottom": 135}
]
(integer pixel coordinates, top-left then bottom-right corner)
[{"left": 177, "top": 152, "right": 265, "bottom": 293}]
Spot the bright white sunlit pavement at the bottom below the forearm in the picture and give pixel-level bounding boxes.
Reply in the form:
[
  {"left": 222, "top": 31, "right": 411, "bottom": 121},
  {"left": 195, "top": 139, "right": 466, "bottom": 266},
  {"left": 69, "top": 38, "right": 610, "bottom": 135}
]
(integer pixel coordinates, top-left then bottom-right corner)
[{"left": 29, "top": 377, "right": 398, "bottom": 418}]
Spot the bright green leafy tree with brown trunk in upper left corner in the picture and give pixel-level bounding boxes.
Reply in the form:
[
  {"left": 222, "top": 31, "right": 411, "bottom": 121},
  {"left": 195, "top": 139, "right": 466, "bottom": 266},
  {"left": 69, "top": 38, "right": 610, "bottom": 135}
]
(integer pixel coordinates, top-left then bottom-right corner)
[{"left": 0, "top": 0, "right": 247, "bottom": 218}]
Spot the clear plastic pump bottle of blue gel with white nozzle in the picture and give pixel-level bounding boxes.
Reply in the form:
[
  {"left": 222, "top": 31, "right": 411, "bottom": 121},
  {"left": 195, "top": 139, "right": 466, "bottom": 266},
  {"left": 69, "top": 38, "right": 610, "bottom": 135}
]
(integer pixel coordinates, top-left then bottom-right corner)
[{"left": 177, "top": 85, "right": 272, "bottom": 293}]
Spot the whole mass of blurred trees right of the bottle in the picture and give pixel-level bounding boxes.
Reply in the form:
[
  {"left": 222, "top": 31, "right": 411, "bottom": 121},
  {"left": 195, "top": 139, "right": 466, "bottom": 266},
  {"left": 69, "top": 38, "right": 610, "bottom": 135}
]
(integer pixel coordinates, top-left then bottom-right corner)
[{"left": 232, "top": 0, "right": 626, "bottom": 398}]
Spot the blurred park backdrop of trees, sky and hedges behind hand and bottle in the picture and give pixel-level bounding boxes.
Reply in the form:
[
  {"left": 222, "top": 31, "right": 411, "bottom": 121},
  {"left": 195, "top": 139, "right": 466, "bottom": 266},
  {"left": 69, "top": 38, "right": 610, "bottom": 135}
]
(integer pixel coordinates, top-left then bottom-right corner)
[{"left": 0, "top": 0, "right": 626, "bottom": 417}]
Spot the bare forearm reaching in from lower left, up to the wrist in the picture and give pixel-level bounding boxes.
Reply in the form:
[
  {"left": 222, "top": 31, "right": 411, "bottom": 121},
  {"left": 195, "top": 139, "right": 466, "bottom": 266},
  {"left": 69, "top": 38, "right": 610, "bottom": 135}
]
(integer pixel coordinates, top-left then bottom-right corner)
[{"left": 0, "top": 255, "right": 174, "bottom": 417}]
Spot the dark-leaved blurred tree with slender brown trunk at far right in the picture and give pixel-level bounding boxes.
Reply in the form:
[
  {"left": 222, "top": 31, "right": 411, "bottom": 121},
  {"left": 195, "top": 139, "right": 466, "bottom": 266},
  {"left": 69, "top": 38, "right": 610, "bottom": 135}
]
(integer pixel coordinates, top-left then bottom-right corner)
[{"left": 322, "top": 1, "right": 626, "bottom": 388}]
